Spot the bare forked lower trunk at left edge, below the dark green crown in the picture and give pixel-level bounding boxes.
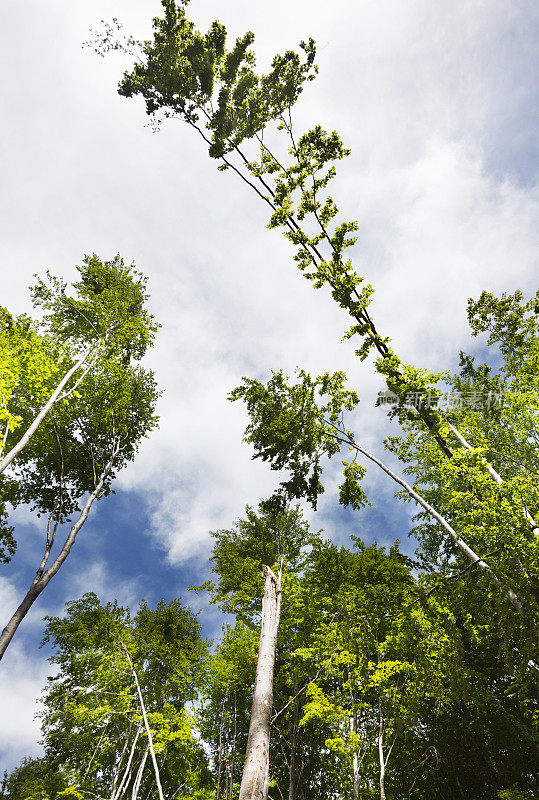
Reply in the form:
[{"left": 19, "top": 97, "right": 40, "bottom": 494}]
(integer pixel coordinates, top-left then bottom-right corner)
[{"left": 0, "top": 445, "right": 118, "bottom": 659}]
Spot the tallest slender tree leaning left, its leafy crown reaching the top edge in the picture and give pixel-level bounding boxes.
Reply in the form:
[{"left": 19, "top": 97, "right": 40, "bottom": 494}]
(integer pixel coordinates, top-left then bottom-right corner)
[{"left": 96, "top": 0, "right": 536, "bottom": 620}]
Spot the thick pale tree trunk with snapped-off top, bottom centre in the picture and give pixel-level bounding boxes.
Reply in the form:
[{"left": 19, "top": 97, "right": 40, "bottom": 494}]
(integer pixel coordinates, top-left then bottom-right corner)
[{"left": 239, "top": 567, "right": 281, "bottom": 800}]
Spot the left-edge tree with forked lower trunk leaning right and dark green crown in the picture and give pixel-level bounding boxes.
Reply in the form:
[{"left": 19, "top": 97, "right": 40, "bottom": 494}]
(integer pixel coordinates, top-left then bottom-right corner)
[{"left": 0, "top": 256, "right": 158, "bottom": 658}]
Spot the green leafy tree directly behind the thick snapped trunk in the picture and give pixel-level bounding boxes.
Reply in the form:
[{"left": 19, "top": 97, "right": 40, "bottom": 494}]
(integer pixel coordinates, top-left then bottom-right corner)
[{"left": 198, "top": 502, "right": 350, "bottom": 800}]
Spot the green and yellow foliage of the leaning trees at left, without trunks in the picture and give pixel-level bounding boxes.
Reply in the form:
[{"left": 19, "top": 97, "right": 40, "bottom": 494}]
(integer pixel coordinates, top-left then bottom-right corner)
[{"left": 0, "top": 254, "right": 158, "bottom": 559}]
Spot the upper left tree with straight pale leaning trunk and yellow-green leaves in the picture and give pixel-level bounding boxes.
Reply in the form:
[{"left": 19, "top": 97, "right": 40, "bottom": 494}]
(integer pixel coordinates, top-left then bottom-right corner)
[{"left": 0, "top": 253, "right": 156, "bottom": 473}]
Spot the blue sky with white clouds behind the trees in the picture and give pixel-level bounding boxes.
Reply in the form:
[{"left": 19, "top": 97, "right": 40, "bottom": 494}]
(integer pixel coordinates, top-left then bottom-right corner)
[{"left": 0, "top": 0, "right": 539, "bottom": 769}]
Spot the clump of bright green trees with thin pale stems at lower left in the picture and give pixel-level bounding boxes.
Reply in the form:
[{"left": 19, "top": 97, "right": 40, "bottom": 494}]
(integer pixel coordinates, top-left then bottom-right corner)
[{"left": 35, "top": 594, "right": 210, "bottom": 800}]
